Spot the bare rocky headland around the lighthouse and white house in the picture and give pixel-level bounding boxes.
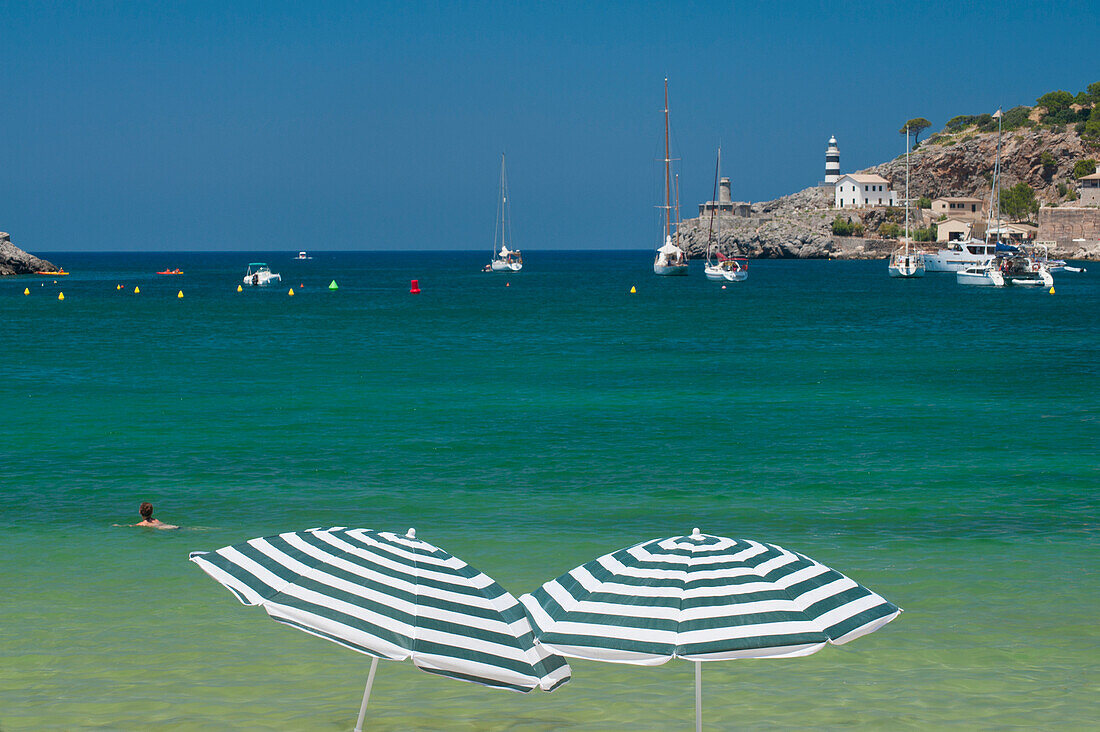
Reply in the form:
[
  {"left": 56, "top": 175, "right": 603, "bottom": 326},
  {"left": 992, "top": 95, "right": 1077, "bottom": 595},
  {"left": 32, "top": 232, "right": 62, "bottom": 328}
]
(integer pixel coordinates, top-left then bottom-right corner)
[{"left": 681, "top": 110, "right": 1100, "bottom": 260}]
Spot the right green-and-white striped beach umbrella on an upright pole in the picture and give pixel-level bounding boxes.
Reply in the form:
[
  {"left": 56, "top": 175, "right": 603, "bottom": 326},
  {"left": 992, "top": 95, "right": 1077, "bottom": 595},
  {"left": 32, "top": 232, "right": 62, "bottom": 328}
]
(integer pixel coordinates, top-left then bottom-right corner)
[{"left": 519, "top": 528, "right": 901, "bottom": 730}]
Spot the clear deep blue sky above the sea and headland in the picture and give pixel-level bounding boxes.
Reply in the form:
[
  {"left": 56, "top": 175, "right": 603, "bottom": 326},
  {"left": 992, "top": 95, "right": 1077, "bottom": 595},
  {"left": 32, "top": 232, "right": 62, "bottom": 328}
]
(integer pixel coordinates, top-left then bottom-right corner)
[{"left": 0, "top": 0, "right": 1100, "bottom": 251}]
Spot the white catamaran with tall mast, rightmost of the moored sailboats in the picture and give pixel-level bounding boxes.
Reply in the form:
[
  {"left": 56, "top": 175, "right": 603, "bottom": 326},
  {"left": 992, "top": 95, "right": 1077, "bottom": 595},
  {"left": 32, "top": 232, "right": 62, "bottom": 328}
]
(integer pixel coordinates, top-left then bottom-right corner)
[{"left": 955, "top": 109, "right": 1054, "bottom": 287}]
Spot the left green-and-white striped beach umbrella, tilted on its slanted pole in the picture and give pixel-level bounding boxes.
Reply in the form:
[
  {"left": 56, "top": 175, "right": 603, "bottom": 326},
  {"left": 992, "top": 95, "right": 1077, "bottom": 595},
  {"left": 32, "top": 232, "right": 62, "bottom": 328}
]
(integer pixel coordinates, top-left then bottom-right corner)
[{"left": 190, "top": 526, "right": 570, "bottom": 731}]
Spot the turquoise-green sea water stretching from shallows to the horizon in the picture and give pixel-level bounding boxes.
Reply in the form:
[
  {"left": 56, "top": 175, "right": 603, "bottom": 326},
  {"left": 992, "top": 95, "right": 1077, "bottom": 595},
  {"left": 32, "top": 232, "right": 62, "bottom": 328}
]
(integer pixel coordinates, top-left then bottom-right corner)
[{"left": 0, "top": 252, "right": 1100, "bottom": 731}]
